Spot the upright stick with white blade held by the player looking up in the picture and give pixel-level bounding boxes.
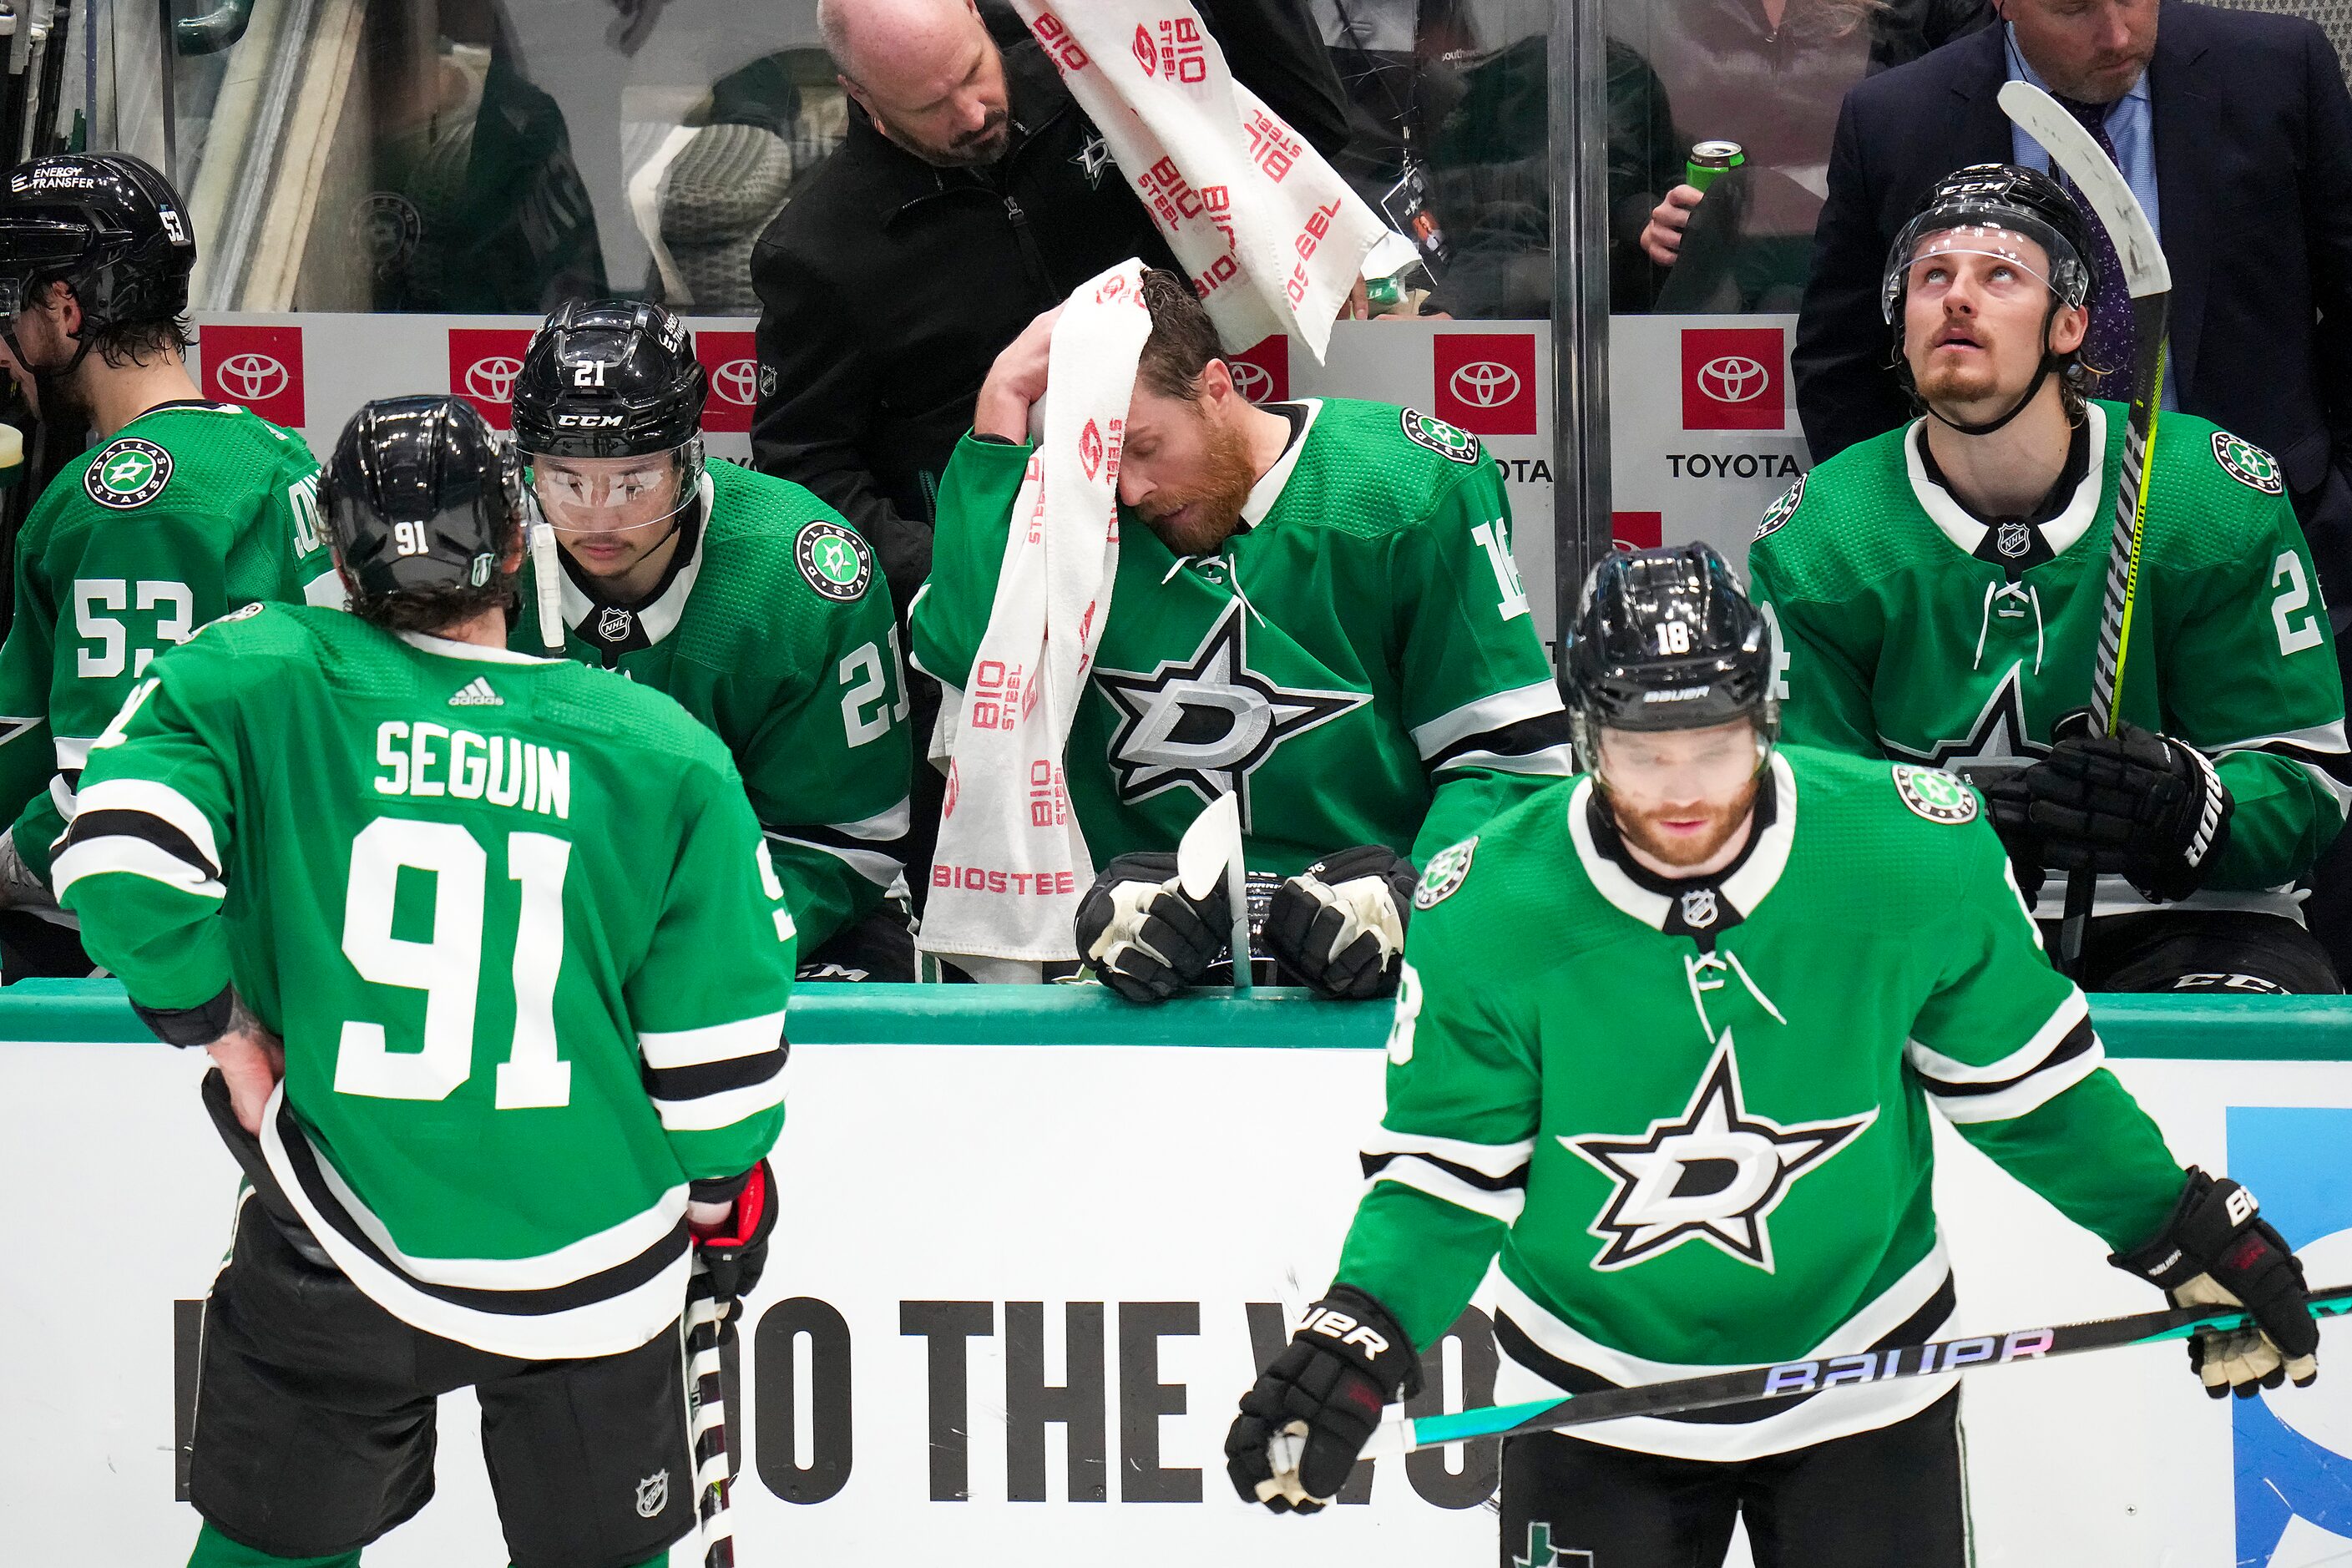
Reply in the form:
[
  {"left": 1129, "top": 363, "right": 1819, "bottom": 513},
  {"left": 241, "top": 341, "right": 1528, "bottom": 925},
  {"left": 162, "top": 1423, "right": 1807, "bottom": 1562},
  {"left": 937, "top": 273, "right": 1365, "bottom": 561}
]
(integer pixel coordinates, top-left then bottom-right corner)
[{"left": 1999, "top": 83, "right": 2173, "bottom": 978}]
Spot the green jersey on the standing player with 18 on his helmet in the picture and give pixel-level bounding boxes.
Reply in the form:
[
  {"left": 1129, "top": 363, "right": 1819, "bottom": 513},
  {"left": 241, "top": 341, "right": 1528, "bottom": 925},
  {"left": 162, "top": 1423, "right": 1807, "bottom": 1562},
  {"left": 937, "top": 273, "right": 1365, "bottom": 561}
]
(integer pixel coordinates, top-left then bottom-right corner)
[{"left": 1338, "top": 747, "right": 2183, "bottom": 1459}]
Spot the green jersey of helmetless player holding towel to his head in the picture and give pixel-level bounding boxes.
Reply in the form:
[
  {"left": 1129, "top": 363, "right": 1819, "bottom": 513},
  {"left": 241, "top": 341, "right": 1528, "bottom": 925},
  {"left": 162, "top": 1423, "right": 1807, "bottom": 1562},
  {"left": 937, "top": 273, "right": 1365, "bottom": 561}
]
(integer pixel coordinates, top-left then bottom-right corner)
[{"left": 910, "top": 397, "right": 1574, "bottom": 877}]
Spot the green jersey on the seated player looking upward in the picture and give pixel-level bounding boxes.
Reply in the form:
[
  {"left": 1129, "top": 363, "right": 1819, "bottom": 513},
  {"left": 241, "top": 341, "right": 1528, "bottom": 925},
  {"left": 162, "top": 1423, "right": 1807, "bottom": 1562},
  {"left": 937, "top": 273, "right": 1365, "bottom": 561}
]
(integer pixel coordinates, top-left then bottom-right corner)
[{"left": 1748, "top": 402, "right": 2352, "bottom": 919}]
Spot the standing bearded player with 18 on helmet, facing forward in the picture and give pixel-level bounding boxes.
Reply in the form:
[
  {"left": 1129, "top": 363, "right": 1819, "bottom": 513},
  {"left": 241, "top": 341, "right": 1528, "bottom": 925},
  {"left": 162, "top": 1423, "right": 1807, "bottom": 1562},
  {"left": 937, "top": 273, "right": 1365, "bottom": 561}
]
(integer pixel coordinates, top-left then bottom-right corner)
[{"left": 1226, "top": 545, "right": 2319, "bottom": 1568}]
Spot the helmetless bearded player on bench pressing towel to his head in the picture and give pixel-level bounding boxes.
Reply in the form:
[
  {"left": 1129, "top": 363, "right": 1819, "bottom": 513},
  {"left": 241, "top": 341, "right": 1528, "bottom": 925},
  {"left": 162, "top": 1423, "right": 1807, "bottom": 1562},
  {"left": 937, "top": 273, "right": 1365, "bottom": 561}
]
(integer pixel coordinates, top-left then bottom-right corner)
[{"left": 910, "top": 271, "right": 1571, "bottom": 1001}]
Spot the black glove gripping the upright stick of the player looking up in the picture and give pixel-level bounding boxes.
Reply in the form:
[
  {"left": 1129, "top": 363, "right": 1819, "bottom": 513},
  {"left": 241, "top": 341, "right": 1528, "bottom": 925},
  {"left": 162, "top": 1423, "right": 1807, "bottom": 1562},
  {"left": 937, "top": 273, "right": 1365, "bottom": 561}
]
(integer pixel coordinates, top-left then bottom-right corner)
[{"left": 2025, "top": 710, "right": 2232, "bottom": 903}]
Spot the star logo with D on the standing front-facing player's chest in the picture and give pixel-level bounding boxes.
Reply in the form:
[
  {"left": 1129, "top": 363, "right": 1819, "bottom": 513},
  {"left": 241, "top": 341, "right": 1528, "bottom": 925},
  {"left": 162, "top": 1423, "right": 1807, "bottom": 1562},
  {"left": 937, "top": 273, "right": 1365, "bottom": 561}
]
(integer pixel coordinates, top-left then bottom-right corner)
[{"left": 1560, "top": 1029, "right": 1879, "bottom": 1274}]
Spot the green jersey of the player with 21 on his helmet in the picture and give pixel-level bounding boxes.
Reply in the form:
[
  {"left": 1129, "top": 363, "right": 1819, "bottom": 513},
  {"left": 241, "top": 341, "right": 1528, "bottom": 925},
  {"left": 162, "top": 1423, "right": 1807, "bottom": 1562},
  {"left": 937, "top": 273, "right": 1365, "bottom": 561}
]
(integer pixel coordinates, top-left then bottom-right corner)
[{"left": 508, "top": 463, "right": 913, "bottom": 949}]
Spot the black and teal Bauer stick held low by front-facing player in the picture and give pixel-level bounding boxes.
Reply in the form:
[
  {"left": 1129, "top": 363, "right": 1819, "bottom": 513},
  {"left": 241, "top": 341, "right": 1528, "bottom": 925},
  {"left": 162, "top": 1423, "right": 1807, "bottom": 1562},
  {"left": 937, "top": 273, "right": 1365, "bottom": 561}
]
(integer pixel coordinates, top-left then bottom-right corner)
[{"left": 1364, "top": 1286, "right": 2352, "bottom": 1459}]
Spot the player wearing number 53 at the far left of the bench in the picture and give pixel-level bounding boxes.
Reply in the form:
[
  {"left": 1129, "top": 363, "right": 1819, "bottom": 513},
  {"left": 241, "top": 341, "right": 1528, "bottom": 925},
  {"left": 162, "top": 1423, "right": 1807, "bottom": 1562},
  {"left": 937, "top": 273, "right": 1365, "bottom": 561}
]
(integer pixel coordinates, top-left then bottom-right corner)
[{"left": 0, "top": 153, "right": 341, "bottom": 980}]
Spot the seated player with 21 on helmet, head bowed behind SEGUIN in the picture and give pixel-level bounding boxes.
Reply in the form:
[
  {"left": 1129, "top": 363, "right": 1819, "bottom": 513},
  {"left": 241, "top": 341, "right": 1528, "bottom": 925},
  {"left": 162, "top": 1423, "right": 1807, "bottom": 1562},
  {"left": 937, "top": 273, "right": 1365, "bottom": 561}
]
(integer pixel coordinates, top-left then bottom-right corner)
[{"left": 510, "top": 299, "right": 915, "bottom": 980}]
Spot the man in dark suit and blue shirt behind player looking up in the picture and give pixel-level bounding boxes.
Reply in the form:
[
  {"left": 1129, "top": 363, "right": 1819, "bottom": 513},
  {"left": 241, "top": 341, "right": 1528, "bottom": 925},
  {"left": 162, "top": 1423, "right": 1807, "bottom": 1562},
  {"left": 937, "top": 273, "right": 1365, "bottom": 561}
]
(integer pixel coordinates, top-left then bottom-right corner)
[{"left": 1794, "top": 0, "right": 2352, "bottom": 606}]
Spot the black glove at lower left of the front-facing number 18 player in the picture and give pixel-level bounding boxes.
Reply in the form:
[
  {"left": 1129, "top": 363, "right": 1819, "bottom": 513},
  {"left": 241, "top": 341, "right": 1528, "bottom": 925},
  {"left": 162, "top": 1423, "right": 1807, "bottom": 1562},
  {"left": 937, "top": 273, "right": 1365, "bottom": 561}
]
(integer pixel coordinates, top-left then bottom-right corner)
[{"left": 1226, "top": 1286, "right": 1420, "bottom": 1514}]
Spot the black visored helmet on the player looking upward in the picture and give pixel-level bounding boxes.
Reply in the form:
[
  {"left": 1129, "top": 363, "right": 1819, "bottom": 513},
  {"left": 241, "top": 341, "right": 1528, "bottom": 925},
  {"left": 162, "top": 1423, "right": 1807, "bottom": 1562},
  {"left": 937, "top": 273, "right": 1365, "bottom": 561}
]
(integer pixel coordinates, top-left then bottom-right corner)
[{"left": 1879, "top": 162, "right": 2098, "bottom": 435}]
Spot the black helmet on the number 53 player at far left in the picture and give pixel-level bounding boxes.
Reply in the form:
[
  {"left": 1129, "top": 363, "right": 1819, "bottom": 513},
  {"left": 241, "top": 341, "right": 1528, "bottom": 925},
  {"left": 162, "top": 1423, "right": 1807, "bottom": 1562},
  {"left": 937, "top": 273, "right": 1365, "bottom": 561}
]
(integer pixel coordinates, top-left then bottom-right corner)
[{"left": 0, "top": 153, "right": 195, "bottom": 334}]
